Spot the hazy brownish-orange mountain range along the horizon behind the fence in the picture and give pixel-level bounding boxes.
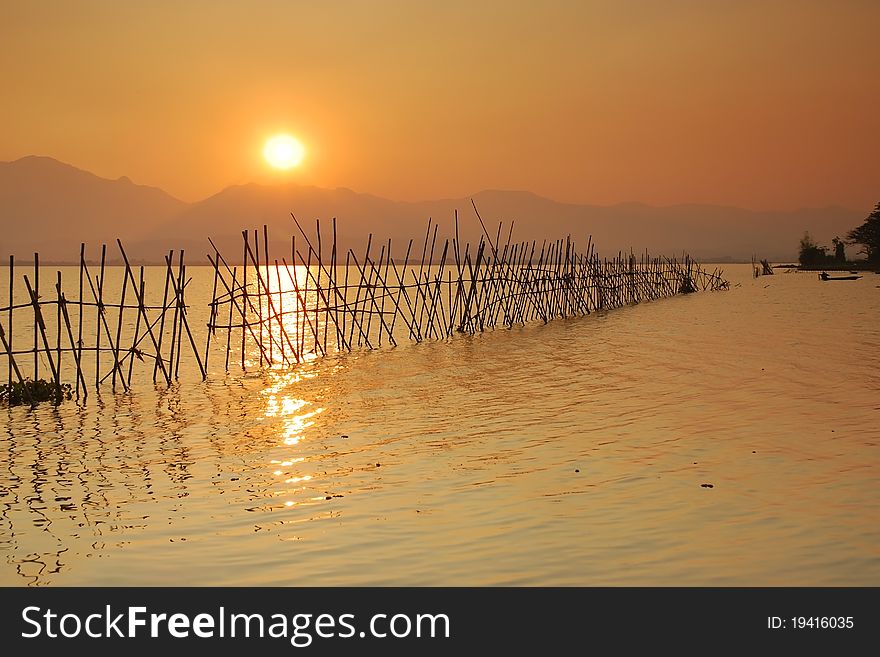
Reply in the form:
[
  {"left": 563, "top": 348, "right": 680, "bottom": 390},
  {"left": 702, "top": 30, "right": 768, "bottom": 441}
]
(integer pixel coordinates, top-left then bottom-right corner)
[{"left": 0, "top": 157, "right": 864, "bottom": 263}]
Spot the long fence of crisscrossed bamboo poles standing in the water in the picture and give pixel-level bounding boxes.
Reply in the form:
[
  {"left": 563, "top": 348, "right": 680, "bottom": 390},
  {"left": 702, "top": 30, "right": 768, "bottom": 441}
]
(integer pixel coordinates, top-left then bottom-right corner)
[{"left": 0, "top": 215, "right": 728, "bottom": 397}]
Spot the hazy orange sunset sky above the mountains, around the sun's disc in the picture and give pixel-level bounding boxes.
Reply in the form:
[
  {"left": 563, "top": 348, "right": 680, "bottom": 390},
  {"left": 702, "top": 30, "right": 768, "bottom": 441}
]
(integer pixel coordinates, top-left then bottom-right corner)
[{"left": 0, "top": 0, "right": 880, "bottom": 209}]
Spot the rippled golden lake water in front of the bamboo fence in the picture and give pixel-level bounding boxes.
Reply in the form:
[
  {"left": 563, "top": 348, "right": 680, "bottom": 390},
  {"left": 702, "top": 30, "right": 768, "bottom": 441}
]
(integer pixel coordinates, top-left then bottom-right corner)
[{"left": 0, "top": 266, "right": 880, "bottom": 586}]
